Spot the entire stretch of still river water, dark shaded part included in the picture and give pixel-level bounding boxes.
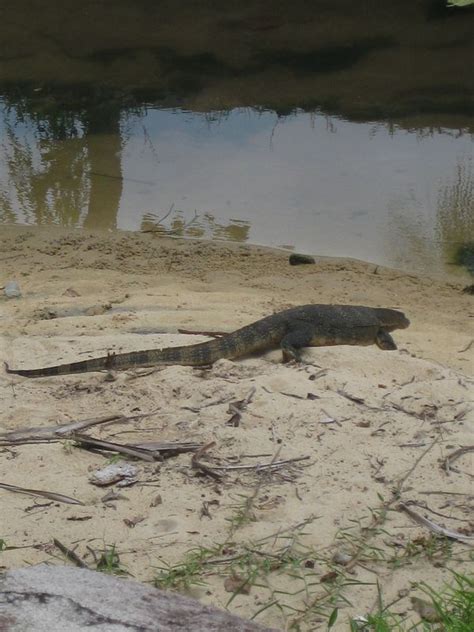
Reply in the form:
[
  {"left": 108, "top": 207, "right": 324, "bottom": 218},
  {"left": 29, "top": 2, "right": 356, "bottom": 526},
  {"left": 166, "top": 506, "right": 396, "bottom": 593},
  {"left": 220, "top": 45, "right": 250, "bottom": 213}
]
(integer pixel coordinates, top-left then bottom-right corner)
[{"left": 0, "top": 0, "right": 474, "bottom": 276}]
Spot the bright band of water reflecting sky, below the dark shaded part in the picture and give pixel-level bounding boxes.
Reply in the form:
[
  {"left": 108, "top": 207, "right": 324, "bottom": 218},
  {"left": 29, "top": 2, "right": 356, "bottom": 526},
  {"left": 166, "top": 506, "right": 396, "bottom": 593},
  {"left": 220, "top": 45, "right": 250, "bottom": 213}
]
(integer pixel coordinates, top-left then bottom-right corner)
[{"left": 0, "top": 109, "right": 474, "bottom": 273}]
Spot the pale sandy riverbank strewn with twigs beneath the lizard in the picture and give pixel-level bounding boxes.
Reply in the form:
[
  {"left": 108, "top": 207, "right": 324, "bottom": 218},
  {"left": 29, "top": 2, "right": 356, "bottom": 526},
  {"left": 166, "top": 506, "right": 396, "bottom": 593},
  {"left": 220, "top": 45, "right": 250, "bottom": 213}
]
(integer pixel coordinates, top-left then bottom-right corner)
[{"left": 0, "top": 227, "right": 474, "bottom": 630}]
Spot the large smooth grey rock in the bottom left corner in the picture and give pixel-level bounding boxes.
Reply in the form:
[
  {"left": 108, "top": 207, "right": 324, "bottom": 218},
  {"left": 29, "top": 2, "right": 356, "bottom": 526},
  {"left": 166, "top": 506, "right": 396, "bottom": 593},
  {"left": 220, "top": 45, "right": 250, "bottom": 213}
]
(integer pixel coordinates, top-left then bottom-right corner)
[{"left": 0, "top": 564, "right": 276, "bottom": 632}]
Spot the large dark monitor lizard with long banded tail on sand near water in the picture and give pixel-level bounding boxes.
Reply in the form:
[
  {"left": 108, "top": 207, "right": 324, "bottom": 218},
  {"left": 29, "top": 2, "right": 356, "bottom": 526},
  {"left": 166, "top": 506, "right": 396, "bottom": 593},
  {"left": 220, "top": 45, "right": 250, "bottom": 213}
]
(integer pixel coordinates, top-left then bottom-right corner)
[{"left": 6, "top": 305, "right": 410, "bottom": 377}]
